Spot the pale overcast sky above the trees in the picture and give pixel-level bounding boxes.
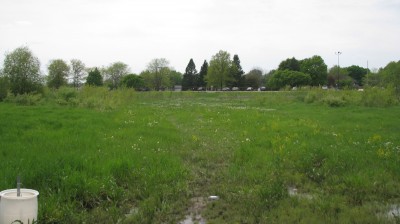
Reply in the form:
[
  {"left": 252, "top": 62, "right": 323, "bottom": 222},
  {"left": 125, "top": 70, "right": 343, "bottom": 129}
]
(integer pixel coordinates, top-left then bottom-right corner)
[{"left": 0, "top": 0, "right": 400, "bottom": 73}]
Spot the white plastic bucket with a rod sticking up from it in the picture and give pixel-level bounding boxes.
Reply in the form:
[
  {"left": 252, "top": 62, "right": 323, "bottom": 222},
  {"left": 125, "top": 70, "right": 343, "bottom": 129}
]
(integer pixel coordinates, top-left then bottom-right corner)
[{"left": 0, "top": 188, "right": 39, "bottom": 224}]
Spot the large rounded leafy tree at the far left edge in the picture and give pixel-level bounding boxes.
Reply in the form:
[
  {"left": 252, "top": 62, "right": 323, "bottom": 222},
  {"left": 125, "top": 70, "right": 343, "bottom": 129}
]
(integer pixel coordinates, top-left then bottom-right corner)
[{"left": 3, "top": 47, "right": 43, "bottom": 95}]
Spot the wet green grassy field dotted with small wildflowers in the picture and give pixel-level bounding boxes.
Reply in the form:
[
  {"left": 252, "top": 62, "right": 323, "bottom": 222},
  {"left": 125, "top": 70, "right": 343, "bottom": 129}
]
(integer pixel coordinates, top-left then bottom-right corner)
[{"left": 0, "top": 88, "right": 400, "bottom": 223}]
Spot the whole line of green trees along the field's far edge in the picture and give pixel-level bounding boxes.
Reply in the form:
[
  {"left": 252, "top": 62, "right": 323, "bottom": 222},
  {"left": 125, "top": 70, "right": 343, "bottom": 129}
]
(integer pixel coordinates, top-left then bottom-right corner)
[{"left": 0, "top": 47, "right": 400, "bottom": 99}]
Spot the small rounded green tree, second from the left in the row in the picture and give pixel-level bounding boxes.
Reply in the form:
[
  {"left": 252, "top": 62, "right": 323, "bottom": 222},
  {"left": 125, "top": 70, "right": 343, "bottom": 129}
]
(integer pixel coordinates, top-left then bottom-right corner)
[{"left": 47, "top": 59, "right": 70, "bottom": 89}]
